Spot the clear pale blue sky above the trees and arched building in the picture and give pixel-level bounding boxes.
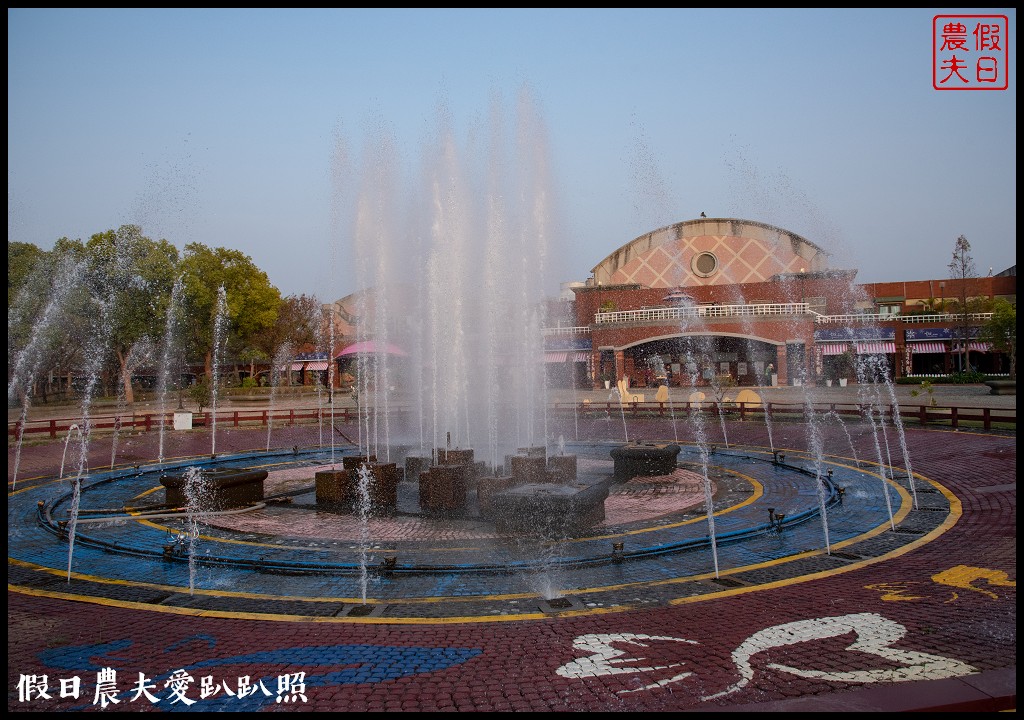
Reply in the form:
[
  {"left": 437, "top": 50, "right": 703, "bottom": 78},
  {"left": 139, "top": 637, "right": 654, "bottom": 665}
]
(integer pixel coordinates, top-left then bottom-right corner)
[{"left": 7, "top": 8, "right": 1017, "bottom": 300}]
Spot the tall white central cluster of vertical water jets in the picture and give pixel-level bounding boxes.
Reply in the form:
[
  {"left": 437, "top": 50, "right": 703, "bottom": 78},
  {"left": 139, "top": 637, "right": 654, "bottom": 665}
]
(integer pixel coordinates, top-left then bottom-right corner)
[{"left": 342, "top": 94, "right": 552, "bottom": 465}]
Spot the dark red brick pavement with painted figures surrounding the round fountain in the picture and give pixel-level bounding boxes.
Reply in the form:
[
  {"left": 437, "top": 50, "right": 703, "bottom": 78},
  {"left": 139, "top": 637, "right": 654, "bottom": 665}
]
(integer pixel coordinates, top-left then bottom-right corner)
[{"left": 8, "top": 422, "right": 1017, "bottom": 712}]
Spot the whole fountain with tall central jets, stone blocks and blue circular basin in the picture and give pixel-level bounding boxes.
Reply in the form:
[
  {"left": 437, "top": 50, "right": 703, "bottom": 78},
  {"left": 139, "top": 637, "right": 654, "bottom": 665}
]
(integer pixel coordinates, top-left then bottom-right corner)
[{"left": 8, "top": 98, "right": 942, "bottom": 626}]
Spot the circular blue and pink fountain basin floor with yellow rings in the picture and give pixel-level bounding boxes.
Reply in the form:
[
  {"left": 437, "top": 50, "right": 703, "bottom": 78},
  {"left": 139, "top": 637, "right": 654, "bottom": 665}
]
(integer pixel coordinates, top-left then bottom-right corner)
[{"left": 9, "top": 442, "right": 948, "bottom": 618}]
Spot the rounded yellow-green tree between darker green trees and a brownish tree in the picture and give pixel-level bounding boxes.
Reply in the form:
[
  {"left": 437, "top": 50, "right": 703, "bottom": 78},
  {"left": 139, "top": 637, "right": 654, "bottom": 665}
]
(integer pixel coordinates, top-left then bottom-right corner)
[{"left": 181, "top": 243, "right": 281, "bottom": 382}]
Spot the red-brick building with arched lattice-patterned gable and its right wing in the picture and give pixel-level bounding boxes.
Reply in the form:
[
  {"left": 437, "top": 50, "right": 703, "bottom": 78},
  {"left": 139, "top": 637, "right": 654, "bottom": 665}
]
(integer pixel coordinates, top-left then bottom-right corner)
[{"left": 547, "top": 218, "right": 1016, "bottom": 386}]
